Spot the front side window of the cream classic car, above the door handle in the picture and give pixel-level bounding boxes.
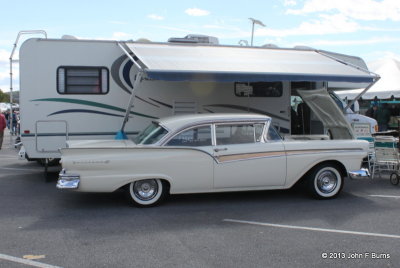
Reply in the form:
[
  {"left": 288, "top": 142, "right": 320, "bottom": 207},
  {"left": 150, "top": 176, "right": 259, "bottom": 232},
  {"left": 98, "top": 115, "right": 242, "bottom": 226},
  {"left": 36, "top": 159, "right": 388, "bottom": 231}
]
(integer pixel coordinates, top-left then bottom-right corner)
[{"left": 215, "top": 124, "right": 264, "bottom": 145}]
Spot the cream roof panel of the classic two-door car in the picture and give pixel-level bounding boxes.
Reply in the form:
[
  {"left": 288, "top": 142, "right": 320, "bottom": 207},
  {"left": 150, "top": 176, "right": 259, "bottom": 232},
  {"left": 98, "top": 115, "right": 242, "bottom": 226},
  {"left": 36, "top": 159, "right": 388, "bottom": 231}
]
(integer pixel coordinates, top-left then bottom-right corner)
[{"left": 158, "top": 113, "right": 271, "bottom": 130}]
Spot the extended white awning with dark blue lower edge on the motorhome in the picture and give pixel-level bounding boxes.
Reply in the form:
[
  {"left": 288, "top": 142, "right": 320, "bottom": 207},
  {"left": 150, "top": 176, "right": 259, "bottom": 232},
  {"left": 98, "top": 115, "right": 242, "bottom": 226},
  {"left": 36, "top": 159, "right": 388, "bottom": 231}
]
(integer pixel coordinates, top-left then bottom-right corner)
[{"left": 125, "top": 43, "right": 375, "bottom": 83}]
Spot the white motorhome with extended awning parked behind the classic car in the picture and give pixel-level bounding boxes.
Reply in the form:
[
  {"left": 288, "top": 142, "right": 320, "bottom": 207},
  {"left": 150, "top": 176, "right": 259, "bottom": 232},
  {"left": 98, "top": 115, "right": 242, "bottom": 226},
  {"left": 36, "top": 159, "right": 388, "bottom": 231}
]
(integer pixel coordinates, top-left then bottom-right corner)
[{"left": 15, "top": 34, "right": 377, "bottom": 166}]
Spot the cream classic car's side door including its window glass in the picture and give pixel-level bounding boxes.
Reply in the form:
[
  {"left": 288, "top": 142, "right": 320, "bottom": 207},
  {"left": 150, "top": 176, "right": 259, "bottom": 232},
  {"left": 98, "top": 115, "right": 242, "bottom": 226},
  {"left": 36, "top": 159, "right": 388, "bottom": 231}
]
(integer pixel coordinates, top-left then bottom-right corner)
[{"left": 214, "top": 123, "right": 286, "bottom": 189}]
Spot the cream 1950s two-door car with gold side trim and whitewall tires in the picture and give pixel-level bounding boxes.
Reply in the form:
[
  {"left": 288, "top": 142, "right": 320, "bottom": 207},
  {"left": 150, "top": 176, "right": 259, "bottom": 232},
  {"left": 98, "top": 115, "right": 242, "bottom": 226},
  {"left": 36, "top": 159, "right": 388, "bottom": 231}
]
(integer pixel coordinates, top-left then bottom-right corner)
[{"left": 57, "top": 114, "right": 368, "bottom": 206}]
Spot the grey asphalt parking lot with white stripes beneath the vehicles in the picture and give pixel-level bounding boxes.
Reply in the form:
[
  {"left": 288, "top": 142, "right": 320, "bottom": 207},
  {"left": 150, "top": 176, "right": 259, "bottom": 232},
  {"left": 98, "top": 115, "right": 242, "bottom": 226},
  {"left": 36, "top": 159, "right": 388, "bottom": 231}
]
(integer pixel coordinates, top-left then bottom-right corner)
[{"left": 0, "top": 131, "right": 400, "bottom": 268}]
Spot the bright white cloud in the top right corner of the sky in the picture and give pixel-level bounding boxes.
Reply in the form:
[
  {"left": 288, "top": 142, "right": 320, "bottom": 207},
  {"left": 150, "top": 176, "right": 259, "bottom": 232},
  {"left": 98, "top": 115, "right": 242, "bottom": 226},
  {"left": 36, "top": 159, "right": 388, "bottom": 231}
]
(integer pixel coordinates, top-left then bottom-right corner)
[{"left": 287, "top": 0, "right": 400, "bottom": 21}]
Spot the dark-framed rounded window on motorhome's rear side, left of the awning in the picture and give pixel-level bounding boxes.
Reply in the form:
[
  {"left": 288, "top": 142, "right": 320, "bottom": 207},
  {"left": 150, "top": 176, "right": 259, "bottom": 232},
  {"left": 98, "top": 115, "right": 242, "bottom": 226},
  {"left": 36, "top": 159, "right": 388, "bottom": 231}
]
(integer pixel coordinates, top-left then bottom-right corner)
[{"left": 57, "top": 66, "right": 109, "bottom": 94}]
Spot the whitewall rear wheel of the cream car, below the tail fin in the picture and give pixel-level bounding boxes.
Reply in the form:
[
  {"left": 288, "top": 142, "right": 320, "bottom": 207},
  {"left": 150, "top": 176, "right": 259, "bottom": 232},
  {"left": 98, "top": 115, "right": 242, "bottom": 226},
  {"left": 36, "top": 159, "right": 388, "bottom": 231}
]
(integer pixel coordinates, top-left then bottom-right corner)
[{"left": 127, "top": 179, "right": 168, "bottom": 207}]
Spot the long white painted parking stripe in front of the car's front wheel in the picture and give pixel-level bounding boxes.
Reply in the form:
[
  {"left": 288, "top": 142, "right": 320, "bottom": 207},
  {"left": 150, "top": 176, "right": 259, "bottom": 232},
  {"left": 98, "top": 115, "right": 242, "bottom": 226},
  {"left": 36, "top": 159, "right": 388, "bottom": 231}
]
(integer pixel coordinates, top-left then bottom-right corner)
[{"left": 223, "top": 219, "right": 400, "bottom": 239}]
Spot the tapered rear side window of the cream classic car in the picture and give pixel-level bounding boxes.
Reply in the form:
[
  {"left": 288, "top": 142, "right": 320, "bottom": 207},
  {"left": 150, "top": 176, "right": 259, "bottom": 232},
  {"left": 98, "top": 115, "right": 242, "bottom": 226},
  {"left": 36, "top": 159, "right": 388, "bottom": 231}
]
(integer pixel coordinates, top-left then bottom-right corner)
[{"left": 166, "top": 126, "right": 212, "bottom": 147}]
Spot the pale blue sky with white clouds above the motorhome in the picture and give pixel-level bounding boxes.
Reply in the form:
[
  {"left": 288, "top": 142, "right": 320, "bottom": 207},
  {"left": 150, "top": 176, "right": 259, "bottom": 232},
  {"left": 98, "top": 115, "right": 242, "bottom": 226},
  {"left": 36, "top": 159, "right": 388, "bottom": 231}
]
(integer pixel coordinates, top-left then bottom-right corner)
[{"left": 0, "top": 0, "right": 400, "bottom": 91}]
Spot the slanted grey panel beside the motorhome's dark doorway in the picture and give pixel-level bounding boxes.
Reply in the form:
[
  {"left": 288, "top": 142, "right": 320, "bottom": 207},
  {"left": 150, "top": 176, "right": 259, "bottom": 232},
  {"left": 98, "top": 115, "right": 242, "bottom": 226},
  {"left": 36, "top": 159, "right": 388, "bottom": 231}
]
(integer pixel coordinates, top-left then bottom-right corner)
[{"left": 297, "top": 88, "right": 355, "bottom": 139}]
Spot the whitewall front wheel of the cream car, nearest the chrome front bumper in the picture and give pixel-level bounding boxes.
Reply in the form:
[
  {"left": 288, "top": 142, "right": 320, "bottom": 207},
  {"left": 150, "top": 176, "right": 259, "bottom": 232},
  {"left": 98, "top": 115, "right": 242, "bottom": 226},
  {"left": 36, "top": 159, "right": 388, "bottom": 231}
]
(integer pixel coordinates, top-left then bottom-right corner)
[{"left": 308, "top": 164, "right": 343, "bottom": 199}]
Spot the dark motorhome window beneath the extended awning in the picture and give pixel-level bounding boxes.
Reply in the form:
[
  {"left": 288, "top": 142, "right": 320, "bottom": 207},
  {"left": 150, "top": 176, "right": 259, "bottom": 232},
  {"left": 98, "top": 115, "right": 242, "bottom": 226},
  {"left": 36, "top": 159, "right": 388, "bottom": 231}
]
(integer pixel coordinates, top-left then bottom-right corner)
[{"left": 235, "top": 82, "right": 283, "bottom": 97}]
